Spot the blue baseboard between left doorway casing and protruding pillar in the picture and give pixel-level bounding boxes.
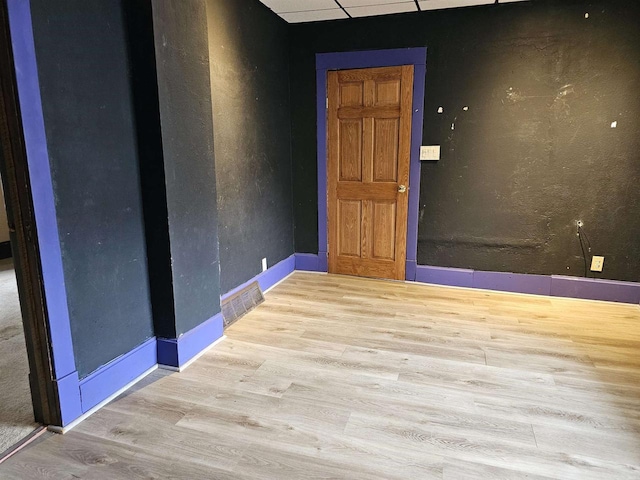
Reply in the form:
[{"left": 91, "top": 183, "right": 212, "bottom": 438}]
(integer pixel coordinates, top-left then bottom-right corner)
[{"left": 79, "top": 337, "right": 158, "bottom": 413}]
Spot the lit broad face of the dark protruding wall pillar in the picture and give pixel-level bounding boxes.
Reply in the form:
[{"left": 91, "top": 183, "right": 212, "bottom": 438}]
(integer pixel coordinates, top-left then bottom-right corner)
[{"left": 153, "top": 0, "right": 220, "bottom": 336}]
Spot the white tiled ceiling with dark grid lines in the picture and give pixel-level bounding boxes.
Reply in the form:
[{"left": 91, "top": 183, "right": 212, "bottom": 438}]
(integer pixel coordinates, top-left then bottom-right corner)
[{"left": 260, "top": 0, "right": 526, "bottom": 23}]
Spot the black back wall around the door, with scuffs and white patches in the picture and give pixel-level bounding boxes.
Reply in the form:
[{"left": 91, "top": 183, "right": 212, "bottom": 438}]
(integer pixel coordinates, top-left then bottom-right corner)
[{"left": 290, "top": 0, "right": 640, "bottom": 281}]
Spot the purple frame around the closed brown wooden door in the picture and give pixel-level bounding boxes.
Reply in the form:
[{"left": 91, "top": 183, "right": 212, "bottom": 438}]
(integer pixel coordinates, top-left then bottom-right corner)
[{"left": 316, "top": 47, "right": 427, "bottom": 280}]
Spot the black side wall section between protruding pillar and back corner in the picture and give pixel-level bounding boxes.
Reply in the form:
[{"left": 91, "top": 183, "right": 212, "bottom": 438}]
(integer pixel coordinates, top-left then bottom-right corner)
[{"left": 207, "top": 0, "right": 294, "bottom": 293}]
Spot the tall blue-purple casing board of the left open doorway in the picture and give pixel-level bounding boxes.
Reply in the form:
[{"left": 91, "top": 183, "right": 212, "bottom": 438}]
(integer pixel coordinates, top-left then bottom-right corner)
[{"left": 7, "top": 0, "right": 77, "bottom": 378}]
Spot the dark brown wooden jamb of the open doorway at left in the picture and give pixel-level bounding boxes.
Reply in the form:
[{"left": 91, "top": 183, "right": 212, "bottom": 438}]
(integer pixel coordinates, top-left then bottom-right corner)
[{"left": 0, "top": 2, "right": 60, "bottom": 425}]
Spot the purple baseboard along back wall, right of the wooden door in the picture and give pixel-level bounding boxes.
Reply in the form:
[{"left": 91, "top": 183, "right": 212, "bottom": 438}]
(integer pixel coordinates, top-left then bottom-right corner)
[{"left": 415, "top": 265, "right": 640, "bottom": 304}]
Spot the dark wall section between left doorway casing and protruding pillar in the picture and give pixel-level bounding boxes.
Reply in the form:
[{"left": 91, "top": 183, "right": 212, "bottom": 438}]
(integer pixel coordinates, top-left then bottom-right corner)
[{"left": 31, "top": 0, "right": 153, "bottom": 377}]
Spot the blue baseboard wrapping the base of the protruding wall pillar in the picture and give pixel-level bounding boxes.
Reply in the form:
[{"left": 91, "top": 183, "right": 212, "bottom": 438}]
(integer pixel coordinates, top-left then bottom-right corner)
[{"left": 157, "top": 313, "right": 224, "bottom": 369}]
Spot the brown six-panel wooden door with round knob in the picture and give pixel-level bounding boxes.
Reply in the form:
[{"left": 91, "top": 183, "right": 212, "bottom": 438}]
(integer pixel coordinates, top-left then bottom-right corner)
[{"left": 327, "top": 66, "right": 413, "bottom": 280}]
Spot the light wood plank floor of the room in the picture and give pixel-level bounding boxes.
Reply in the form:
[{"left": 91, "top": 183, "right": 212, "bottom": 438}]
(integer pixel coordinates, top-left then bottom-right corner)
[{"left": 0, "top": 272, "right": 640, "bottom": 480}]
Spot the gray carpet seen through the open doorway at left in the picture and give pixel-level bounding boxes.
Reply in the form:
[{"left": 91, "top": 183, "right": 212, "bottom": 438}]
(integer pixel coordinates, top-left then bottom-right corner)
[{"left": 0, "top": 260, "right": 38, "bottom": 453}]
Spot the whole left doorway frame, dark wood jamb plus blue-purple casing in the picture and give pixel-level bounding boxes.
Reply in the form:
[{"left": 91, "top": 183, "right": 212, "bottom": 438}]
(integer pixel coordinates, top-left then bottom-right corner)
[{"left": 0, "top": 0, "right": 83, "bottom": 426}]
